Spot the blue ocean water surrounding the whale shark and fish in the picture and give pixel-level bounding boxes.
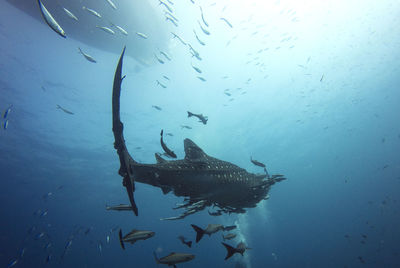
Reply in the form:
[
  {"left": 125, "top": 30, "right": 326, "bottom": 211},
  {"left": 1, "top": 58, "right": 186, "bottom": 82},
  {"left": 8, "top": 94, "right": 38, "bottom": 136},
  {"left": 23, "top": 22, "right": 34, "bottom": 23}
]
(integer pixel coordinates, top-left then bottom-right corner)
[{"left": 0, "top": 0, "right": 400, "bottom": 268}]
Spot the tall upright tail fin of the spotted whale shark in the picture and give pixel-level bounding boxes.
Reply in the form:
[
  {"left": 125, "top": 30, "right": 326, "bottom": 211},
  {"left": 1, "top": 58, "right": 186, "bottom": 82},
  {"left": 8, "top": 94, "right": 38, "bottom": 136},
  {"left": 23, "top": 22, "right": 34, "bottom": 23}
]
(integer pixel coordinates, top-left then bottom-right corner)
[{"left": 112, "top": 47, "right": 138, "bottom": 216}]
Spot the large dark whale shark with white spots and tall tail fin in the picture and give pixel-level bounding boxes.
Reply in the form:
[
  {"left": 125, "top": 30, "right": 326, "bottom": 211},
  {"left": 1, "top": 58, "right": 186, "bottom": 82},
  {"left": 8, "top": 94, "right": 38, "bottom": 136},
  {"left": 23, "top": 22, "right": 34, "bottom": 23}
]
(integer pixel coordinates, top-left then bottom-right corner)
[{"left": 112, "top": 48, "right": 285, "bottom": 220}]
